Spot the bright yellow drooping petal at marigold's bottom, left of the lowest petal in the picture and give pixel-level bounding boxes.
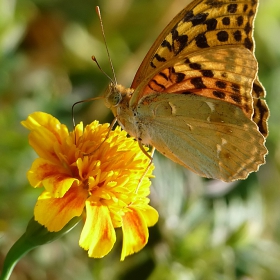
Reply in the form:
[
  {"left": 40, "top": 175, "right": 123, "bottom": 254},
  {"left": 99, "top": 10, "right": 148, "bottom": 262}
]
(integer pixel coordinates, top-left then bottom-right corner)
[{"left": 79, "top": 201, "right": 116, "bottom": 258}]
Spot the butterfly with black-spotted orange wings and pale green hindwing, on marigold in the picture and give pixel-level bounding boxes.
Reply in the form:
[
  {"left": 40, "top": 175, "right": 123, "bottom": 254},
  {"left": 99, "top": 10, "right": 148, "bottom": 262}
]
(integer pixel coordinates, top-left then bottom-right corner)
[{"left": 104, "top": 0, "right": 269, "bottom": 182}]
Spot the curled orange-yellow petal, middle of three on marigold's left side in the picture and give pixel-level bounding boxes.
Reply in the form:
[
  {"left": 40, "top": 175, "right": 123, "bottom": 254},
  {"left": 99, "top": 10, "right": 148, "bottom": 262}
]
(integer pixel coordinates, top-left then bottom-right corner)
[{"left": 27, "top": 158, "right": 78, "bottom": 197}]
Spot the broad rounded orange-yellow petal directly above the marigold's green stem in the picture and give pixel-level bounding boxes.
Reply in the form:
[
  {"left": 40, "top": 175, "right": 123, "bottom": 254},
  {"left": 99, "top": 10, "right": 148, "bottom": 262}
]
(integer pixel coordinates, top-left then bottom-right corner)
[{"left": 34, "top": 186, "right": 88, "bottom": 232}]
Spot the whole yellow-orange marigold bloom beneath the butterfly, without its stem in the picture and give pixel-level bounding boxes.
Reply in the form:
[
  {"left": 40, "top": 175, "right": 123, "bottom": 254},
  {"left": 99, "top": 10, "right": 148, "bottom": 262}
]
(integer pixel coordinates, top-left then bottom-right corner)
[{"left": 22, "top": 112, "right": 158, "bottom": 260}]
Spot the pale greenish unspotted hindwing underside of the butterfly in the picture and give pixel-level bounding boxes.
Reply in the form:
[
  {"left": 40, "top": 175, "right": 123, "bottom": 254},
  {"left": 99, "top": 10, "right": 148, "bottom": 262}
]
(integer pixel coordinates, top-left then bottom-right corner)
[{"left": 137, "top": 93, "right": 267, "bottom": 182}]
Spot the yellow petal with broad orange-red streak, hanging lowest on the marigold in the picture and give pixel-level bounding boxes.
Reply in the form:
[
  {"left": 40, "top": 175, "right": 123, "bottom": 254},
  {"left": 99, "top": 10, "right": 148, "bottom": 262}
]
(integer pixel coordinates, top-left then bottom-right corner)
[{"left": 121, "top": 208, "right": 149, "bottom": 261}]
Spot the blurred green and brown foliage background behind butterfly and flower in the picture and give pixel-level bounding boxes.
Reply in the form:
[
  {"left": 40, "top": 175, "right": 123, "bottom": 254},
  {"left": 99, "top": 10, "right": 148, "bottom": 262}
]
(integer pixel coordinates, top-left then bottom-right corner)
[{"left": 0, "top": 0, "right": 280, "bottom": 280}]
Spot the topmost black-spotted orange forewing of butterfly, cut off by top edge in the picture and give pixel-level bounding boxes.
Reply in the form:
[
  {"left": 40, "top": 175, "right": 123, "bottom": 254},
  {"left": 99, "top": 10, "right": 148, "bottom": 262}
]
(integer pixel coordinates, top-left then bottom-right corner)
[{"left": 131, "top": 0, "right": 258, "bottom": 88}]
